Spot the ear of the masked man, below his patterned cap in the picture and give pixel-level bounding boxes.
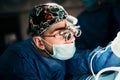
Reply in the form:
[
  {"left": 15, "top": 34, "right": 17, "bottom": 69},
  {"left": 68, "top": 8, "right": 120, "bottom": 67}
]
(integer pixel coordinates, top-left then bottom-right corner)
[{"left": 33, "top": 36, "right": 45, "bottom": 50}]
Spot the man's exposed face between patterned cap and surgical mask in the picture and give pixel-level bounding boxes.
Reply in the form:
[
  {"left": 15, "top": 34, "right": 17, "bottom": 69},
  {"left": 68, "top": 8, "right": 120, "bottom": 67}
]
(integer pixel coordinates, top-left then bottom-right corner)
[{"left": 43, "top": 20, "right": 75, "bottom": 52}]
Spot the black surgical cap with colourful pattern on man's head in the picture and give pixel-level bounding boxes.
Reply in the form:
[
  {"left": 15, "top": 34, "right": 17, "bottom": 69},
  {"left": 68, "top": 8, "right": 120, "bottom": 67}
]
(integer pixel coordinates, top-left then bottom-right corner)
[{"left": 28, "top": 3, "right": 68, "bottom": 35}]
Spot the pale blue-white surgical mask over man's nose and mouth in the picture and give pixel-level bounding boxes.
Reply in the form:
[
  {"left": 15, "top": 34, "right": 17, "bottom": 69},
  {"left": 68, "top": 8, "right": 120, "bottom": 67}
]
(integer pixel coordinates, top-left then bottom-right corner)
[{"left": 42, "top": 39, "right": 76, "bottom": 60}]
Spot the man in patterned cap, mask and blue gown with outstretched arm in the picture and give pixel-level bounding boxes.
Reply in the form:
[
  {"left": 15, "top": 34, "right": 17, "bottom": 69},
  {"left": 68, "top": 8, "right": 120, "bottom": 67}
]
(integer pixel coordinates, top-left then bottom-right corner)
[{"left": 0, "top": 3, "right": 120, "bottom": 80}]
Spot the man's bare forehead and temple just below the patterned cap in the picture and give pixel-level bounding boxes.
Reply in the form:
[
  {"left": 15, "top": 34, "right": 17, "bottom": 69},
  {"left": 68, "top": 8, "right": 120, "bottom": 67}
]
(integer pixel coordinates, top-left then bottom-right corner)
[{"left": 45, "top": 20, "right": 66, "bottom": 33}]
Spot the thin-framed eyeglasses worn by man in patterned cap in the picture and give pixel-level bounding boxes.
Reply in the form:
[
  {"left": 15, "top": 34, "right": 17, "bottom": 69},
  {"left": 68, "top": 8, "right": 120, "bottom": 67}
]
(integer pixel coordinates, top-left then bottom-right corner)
[{"left": 43, "top": 30, "right": 74, "bottom": 40}]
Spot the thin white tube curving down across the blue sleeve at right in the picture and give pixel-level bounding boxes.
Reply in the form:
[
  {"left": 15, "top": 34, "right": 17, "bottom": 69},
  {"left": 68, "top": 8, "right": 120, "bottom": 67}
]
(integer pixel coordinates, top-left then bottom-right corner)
[{"left": 89, "top": 45, "right": 111, "bottom": 80}]
